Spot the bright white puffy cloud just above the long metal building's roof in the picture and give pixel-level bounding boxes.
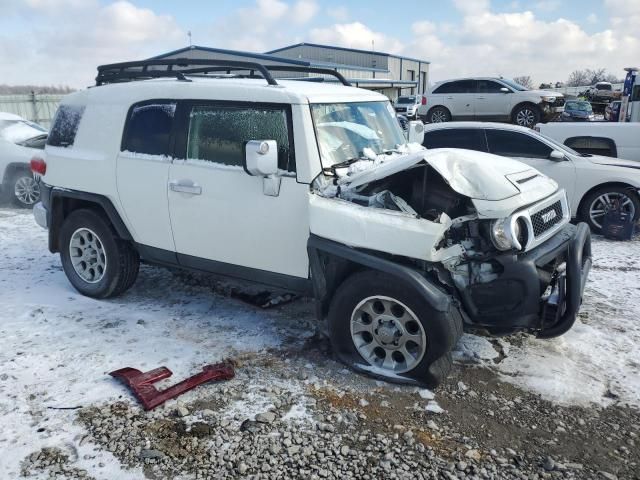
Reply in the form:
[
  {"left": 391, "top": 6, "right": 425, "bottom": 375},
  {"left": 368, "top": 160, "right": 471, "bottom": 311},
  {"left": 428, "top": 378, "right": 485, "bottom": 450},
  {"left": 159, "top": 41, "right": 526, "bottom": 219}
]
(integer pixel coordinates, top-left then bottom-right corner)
[{"left": 309, "top": 22, "right": 403, "bottom": 53}]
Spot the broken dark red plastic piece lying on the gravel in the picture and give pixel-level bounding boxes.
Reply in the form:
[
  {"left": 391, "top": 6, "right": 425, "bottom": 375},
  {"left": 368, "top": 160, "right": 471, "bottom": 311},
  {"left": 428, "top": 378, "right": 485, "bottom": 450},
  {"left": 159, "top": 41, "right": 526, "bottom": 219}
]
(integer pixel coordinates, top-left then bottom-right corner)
[{"left": 109, "top": 362, "right": 235, "bottom": 410}]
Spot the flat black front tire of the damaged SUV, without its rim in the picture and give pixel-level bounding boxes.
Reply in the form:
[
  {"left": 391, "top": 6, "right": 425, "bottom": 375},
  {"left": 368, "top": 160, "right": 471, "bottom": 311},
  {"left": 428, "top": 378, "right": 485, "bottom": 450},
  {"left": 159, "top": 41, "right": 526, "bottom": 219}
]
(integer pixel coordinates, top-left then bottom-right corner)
[{"left": 328, "top": 270, "right": 463, "bottom": 387}]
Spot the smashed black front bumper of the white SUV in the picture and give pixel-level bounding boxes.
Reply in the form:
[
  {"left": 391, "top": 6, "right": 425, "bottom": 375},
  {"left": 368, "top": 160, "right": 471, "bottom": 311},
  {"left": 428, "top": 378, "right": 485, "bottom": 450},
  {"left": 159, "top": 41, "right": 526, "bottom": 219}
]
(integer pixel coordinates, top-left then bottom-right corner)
[{"left": 459, "top": 223, "right": 591, "bottom": 338}]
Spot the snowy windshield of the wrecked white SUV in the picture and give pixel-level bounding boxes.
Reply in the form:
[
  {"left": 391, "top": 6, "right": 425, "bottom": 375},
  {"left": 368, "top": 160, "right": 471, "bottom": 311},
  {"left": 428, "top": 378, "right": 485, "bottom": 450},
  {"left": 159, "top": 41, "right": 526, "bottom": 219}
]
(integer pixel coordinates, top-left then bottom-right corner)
[{"left": 311, "top": 102, "right": 407, "bottom": 168}]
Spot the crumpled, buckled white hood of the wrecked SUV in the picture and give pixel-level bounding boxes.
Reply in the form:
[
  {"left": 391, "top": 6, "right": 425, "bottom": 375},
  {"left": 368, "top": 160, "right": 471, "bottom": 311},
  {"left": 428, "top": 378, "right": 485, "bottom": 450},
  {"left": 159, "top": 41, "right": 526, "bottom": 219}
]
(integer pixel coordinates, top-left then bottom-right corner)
[{"left": 338, "top": 148, "right": 557, "bottom": 201}]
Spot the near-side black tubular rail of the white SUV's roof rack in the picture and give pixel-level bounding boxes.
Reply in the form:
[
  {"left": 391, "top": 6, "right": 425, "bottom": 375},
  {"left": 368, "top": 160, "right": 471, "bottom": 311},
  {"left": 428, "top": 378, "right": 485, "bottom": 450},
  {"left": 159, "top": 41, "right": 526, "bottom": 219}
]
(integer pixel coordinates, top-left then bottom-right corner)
[{"left": 96, "top": 58, "right": 278, "bottom": 86}]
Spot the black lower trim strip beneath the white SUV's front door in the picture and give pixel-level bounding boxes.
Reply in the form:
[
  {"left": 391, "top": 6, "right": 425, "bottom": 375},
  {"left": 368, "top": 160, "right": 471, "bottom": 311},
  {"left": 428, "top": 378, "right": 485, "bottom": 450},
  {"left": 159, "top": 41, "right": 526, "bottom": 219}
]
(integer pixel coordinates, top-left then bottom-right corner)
[{"left": 177, "top": 253, "right": 312, "bottom": 295}]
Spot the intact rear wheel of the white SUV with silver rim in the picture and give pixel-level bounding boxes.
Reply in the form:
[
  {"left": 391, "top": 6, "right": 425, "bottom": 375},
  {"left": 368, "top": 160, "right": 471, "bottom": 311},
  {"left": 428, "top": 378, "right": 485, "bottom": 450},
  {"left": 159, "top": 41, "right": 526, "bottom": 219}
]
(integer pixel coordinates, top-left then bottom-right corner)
[{"left": 59, "top": 210, "right": 140, "bottom": 298}]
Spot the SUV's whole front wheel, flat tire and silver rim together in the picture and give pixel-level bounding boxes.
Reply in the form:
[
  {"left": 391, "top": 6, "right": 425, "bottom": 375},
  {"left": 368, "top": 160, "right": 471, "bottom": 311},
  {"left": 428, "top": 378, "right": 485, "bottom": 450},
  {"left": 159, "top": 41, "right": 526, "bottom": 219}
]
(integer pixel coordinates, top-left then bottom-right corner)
[{"left": 329, "top": 271, "right": 462, "bottom": 386}]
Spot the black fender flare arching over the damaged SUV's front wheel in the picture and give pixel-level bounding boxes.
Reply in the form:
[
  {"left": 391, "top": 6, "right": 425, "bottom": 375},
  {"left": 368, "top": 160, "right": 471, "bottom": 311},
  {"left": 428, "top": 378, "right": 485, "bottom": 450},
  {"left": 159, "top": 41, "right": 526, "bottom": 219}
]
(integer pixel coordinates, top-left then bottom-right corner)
[{"left": 307, "top": 234, "right": 453, "bottom": 312}]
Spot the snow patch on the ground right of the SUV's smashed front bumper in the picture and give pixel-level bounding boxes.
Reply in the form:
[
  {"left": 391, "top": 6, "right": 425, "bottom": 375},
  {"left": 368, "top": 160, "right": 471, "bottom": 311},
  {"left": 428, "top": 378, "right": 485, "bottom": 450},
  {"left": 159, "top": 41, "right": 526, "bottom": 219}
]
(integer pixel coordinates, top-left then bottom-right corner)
[{"left": 458, "top": 232, "right": 640, "bottom": 406}]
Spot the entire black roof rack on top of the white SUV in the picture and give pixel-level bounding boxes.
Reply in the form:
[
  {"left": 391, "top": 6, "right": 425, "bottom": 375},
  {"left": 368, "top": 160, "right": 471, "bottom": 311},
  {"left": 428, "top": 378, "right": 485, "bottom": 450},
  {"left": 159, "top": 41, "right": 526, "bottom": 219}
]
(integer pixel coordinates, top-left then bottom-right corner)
[{"left": 96, "top": 58, "right": 351, "bottom": 86}]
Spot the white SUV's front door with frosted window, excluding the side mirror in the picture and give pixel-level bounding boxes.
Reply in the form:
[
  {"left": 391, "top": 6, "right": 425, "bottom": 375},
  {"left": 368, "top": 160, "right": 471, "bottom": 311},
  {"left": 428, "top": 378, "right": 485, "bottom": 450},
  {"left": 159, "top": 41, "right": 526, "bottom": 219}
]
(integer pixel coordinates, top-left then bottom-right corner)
[{"left": 168, "top": 102, "right": 309, "bottom": 284}]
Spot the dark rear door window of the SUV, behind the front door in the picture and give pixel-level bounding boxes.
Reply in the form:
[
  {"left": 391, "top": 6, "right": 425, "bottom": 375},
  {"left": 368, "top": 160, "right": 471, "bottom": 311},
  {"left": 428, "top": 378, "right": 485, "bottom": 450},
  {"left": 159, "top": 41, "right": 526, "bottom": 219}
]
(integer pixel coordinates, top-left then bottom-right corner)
[{"left": 122, "top": 102, "right": 176, "bottom": 155}]
